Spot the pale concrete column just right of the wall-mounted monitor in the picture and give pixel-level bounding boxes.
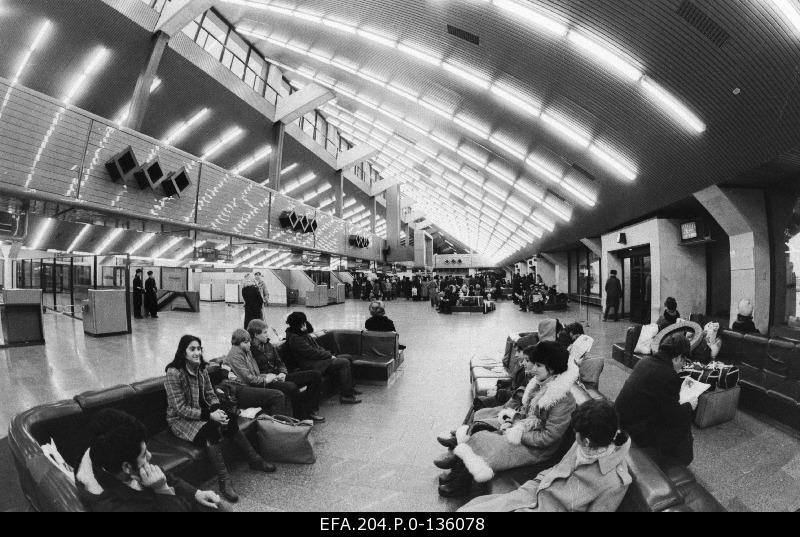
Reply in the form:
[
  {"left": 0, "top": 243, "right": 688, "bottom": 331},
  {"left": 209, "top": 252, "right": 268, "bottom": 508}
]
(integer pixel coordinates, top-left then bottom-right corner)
[{"left": 694, "top": 185, "right": 772, "bottom": 333}]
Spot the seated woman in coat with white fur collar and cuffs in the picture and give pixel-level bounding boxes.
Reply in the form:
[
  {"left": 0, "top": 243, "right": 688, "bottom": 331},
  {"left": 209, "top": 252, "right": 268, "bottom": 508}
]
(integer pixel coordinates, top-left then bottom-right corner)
[{"left": 435, "top": 341, "right": 578, "bottom": 497}]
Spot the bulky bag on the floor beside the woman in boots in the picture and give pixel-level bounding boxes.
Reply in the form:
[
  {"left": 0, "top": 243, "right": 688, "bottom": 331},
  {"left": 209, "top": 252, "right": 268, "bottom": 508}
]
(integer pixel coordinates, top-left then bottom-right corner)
[{"left": 256, "top": 414, "right": 317, "bottom": 464}]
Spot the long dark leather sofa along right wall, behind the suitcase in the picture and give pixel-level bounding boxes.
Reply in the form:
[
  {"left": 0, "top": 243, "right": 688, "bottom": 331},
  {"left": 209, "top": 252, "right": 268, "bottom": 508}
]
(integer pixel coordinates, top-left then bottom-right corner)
[{"left": 612, "top": 325, "right": 800, "bottom": 429}]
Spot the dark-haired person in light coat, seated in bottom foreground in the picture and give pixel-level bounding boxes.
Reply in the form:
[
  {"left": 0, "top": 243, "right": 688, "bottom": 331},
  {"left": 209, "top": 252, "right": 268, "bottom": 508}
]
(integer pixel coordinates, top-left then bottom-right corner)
[{"left": 459, "top": 399, "right": 633, "bottom": 513}]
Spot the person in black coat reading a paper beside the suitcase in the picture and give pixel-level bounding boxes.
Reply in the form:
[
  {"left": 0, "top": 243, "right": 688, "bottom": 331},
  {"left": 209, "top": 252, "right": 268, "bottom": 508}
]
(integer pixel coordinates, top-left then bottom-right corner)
[{"left": 615, "top": 333, "right": 697, "bottom": 467}]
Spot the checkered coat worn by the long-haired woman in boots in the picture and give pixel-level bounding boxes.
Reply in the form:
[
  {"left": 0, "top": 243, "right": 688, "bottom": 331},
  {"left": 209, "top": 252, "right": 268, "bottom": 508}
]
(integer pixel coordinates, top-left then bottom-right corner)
[{"left": 164, "top": 367, "right": 219, "bottom": 442}]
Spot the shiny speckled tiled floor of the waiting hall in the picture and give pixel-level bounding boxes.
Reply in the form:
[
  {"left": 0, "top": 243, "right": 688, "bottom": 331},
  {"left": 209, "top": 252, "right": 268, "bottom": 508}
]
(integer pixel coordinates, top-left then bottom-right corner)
[{"left": 0, "top": 300, "right": 800, "bottom": 511}]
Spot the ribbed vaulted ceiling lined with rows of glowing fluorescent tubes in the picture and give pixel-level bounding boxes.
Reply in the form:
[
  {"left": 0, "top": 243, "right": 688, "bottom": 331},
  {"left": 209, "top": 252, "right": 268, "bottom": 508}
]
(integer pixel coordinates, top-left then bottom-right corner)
[{"left": 0, "top": 0, "right": 800, "bottom": 263}]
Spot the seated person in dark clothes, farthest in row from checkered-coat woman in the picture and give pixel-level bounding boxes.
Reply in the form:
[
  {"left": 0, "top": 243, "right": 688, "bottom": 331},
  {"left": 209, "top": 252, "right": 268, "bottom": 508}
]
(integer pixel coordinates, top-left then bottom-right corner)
[{"left": 286, "top": 311, "right": 361, "bottom": 405}]
